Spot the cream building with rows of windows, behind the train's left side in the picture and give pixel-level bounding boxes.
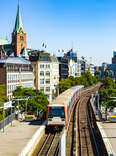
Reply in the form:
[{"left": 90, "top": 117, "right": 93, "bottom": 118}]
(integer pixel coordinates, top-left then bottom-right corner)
[{"left": 31, "top": 52, "right": 59, "bottom": 102}]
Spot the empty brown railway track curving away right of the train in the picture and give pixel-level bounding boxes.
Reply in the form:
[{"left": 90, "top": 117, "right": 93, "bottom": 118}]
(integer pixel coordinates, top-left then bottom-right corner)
[{"left": 66, "top": 84, "right": 99, "bottom": 156}]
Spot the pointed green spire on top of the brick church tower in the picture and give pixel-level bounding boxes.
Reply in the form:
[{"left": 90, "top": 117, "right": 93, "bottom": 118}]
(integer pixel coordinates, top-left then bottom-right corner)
[{"left": 14, "top": 3, "right": 23, "bottom": 32}]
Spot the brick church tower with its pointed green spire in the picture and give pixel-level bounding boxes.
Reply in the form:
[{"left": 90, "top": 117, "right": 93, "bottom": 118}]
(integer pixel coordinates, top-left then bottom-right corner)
[{"left": 12, "top": 4, "right": 27, "bottom": 56}]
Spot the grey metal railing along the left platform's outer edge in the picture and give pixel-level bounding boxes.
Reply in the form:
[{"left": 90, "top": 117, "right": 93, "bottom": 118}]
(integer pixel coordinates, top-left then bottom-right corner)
[{"left": 0, "top": 113, "right": 16, "bottom": 130}]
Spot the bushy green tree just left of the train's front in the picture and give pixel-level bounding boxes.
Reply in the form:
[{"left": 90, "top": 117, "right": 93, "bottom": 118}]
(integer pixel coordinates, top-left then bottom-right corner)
[{"left": 13, "top": 86, "right": 48, "bottom": 112}]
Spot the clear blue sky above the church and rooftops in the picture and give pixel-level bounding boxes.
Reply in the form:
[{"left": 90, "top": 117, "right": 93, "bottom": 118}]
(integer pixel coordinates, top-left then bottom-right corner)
[{"left": 0, "top": 0, "right": 116, "bottom": 65}]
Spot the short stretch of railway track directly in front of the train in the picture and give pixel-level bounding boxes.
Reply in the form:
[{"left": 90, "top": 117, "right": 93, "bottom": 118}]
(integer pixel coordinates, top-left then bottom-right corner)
[{"left": 37, "top": 133, "right": 60, "bottom": 156}]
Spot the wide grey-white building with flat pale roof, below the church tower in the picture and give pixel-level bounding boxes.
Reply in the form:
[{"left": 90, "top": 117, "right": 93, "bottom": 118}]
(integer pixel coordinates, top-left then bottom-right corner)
[{"left": 0, "top": 57, "right": 34, "bottom": 100}]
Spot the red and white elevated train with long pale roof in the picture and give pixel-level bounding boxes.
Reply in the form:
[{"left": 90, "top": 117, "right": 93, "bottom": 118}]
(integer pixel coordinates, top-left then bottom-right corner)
[{"left": 46, "top": 85, "right": 84, "bottom": 132}]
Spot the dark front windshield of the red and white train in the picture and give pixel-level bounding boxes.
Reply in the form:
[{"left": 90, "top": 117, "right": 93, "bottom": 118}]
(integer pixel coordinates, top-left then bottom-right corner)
[{"left": 49, "top": 106, "right": 65, "bottom": 117}]
